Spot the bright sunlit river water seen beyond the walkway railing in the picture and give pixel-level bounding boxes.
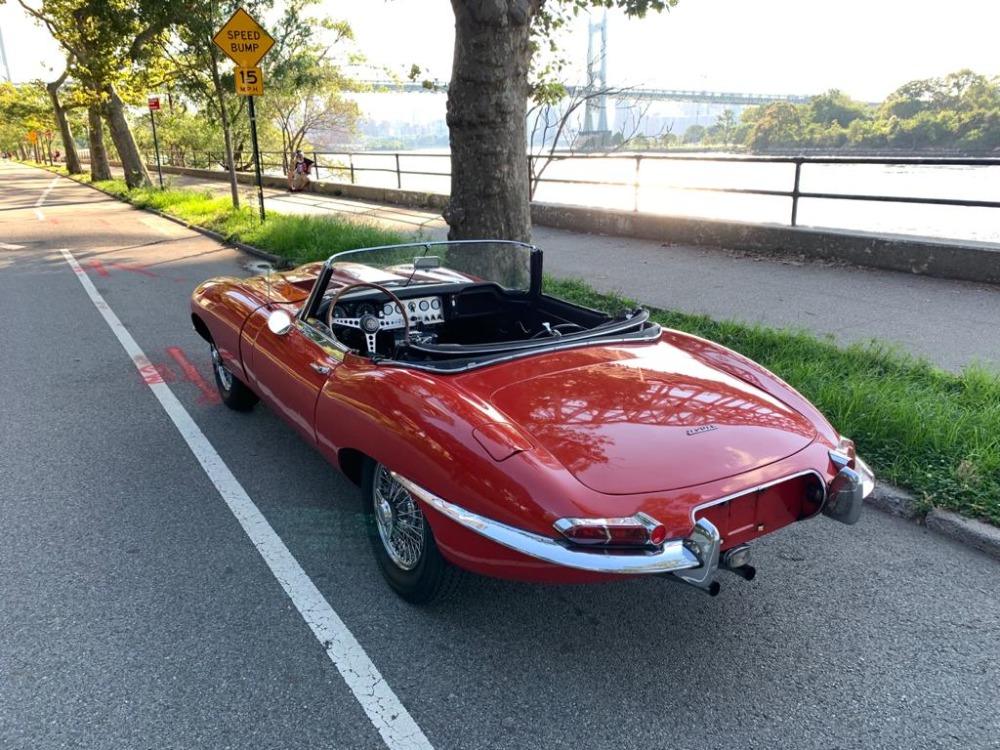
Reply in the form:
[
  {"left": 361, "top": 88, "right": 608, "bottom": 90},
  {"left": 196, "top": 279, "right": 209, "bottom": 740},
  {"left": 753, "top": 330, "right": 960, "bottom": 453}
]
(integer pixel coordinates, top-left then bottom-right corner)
[{"left": 338, "top": 152, "right": 1000, "bottom": 245}]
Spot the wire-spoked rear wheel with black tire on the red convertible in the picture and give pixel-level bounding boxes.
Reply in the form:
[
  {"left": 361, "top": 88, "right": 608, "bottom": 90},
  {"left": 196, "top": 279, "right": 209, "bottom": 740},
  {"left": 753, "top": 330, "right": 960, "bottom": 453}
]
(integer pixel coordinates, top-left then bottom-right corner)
[{"left": 361, "top": 461, "right": 461, "bottom": 604}]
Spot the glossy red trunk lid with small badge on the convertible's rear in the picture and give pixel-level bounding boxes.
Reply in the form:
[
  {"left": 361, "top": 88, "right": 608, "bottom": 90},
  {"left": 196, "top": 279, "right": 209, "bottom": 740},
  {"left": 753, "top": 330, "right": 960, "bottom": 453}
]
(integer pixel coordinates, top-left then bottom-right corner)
[{"left": 491, "top": 350, "right": 816, "bottom": 494}]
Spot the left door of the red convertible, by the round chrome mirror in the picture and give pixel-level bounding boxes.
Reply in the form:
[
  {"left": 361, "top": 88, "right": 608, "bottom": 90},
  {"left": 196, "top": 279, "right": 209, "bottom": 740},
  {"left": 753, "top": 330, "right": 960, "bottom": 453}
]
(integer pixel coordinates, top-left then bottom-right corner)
[{"left": 250, "top": 306, "right": 343, "bottom": 444}]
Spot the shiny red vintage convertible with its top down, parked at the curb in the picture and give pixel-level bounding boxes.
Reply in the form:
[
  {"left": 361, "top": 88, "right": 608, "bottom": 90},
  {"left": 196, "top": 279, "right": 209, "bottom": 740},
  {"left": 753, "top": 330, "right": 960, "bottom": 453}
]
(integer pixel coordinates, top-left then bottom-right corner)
[{"left": 192, "top": 241, "right": 874, "bottom": 602}]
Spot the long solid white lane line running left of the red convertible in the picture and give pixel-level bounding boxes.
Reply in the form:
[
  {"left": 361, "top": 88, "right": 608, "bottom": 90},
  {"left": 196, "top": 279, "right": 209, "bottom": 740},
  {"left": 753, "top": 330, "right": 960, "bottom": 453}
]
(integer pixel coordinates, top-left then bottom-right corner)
[{"left": 60, "top": 250, "right": 433, "bottom": 750}]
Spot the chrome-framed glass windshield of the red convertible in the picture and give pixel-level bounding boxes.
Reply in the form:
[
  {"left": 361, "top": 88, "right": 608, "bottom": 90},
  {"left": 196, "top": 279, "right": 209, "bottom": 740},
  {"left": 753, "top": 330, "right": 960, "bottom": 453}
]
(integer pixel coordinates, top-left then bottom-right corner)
[{"left": 330, "top": 240, "right": 540, "bottom": 292}]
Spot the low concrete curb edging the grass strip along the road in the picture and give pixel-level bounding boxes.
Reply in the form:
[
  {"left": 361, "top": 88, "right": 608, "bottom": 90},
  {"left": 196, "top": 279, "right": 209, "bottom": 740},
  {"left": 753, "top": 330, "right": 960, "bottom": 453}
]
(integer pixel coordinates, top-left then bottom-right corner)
[{"left": 54, "top": 166, "right": 1000, "bottom": 560}]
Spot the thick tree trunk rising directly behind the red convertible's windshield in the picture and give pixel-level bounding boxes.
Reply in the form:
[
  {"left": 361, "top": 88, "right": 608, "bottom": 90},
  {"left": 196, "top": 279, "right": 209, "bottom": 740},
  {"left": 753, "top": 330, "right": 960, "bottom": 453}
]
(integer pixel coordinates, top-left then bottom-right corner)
[{"left": 444, "top": 0, "right": 544, "bottom": 242}]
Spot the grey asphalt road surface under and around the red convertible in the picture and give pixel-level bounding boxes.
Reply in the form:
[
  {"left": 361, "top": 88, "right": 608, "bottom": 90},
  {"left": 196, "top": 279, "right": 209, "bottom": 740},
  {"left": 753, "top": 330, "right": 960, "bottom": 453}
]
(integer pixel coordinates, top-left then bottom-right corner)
[{"left": 0, "top": 162, "right": 1000, "bottom": 750}]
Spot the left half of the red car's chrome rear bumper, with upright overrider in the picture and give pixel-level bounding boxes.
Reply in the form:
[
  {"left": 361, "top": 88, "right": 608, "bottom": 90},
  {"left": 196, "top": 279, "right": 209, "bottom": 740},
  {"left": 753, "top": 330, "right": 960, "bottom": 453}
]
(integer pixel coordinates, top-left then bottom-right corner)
[{"left": 393, "top": 473, "right": 721, "bottom": 586}]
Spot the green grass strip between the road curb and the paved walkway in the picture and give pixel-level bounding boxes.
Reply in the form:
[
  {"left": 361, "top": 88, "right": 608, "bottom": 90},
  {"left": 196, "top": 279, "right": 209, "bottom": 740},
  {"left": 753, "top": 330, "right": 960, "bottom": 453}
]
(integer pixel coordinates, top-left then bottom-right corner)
[{"left": 90, "top": 180, "right": 1000, "bottom": 526}]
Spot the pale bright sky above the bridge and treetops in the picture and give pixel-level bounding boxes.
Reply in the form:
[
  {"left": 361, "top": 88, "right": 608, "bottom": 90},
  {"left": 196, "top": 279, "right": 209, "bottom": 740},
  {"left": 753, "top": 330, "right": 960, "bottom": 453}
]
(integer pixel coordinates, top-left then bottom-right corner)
[{"left": 0, "top": 0, "right": 1000, "bottom": 102}]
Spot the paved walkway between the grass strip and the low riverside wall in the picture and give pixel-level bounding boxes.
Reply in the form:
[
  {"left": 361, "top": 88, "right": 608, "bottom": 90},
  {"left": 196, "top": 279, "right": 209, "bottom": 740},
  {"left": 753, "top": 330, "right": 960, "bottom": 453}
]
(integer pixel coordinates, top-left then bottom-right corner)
[{"left": 170, "top": 170, "right": 1000, "bottom": 372}]
